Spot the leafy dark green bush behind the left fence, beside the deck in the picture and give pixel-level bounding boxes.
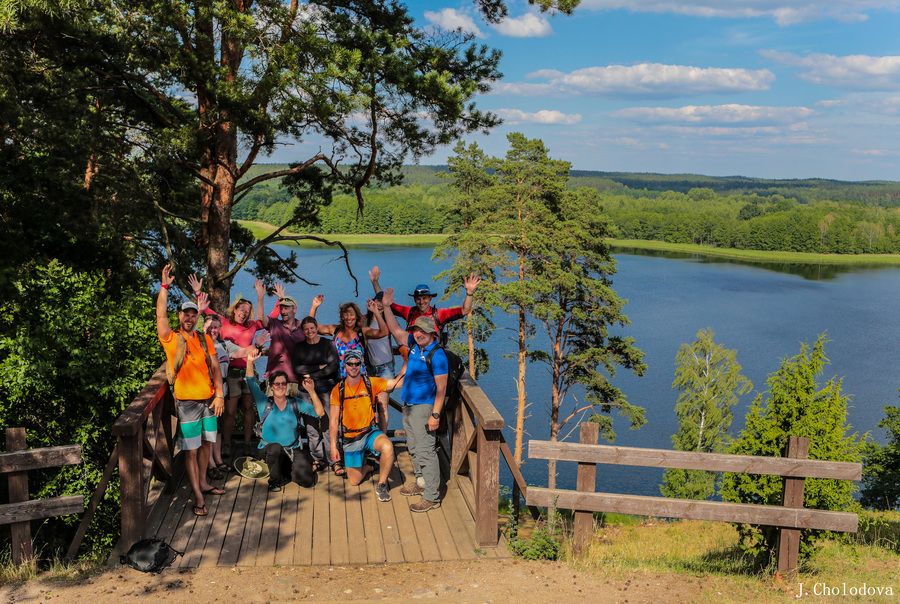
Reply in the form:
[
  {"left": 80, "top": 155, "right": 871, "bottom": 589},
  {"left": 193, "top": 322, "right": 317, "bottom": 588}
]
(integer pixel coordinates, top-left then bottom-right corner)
[{"left": 0, "top": 261, "right": 162, "bottom": 556}]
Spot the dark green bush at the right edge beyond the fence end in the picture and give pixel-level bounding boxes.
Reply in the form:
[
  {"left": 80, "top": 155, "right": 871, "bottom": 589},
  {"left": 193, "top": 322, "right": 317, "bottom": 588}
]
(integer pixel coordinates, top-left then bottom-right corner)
[{"left": 860, "top": 406, "right": 900, "bottom": 510}]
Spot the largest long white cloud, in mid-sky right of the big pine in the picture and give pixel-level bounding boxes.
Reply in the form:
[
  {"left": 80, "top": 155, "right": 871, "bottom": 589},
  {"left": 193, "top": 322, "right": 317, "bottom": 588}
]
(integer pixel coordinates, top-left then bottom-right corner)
[{"left": 494, "top": 63, "right": 775, "bottom": 98}]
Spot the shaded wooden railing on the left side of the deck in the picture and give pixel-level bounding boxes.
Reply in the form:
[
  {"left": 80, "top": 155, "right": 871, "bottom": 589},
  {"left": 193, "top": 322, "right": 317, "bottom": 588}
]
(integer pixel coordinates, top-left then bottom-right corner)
[{"left": 113, "top": 365, "right": 176, "bottom": 547}]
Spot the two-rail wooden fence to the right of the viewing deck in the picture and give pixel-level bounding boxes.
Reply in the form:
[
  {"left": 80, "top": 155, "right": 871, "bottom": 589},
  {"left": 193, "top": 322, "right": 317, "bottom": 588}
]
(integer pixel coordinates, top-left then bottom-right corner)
[{"left": 526, "top": 423, "right": 862, "bottom": 572}]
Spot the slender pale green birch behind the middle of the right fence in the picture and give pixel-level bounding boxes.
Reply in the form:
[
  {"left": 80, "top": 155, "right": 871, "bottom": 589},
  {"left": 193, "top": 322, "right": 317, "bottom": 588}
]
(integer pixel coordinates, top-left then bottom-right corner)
[{"left": 660, "top": 329, "right": 753, "bottom": 499}]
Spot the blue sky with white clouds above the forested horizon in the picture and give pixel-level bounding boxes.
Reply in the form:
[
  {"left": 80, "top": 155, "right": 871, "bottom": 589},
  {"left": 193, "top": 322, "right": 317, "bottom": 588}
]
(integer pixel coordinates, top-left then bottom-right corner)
[{"left": 273, "top": 0, "right": 900, "bottom": 180}]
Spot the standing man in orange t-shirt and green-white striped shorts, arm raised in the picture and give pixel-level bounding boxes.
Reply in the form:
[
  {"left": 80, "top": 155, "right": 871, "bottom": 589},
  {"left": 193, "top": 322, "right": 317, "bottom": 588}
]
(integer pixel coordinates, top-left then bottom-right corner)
[{"left": 156, "top": 264, "right": 225, "bottom": 516}]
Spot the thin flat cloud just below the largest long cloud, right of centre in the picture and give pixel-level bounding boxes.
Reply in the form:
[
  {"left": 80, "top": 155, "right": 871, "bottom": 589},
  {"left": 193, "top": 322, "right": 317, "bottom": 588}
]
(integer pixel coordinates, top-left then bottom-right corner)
[{"left": 612, "top": 104, "right": 815, "bottom": 128}]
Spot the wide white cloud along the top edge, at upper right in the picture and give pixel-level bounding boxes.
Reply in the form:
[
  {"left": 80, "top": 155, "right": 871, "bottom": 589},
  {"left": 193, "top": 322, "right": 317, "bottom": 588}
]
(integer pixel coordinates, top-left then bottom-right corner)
[{"left": 580, "top": 0, "right": 900, "bottom": 25}]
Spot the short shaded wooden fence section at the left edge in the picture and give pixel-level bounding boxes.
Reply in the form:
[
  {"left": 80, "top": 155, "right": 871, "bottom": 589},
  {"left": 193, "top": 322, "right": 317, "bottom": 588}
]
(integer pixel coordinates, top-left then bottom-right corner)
[{"left": 0, "top": 428, "right": 84, "bottom": 564}]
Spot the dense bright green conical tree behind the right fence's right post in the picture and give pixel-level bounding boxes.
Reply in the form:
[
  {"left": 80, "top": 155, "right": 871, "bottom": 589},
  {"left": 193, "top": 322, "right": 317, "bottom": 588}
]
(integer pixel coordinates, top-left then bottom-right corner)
[{"left": 721, "top": 334, "right": 861, "bottom": 559}]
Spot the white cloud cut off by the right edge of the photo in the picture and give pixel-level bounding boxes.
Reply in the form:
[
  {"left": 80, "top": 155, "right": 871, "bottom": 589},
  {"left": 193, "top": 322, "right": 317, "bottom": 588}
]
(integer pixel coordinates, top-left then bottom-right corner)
[{"left": 760, "top": 50, "right": 900, "bottom": 90}]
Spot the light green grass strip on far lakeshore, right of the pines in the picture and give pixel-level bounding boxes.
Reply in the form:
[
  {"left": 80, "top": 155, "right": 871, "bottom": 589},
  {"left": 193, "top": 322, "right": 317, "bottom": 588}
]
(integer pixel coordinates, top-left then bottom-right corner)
[{"left": 608, "top": 239, "right": 900, "bottom": 266}]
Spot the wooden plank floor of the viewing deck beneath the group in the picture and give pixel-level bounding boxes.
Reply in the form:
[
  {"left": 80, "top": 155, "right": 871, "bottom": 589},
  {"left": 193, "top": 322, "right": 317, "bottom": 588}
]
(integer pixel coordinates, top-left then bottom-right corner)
[{"left": 148, "top": 445, "right": 488, "bottom": 568}]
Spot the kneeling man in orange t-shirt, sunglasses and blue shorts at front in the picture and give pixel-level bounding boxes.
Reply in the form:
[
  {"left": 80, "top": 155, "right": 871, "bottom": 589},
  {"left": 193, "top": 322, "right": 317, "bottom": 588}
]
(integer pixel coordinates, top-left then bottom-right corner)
[{"left": 329, "top": 349, "right": 403, "bottom": 501}]
